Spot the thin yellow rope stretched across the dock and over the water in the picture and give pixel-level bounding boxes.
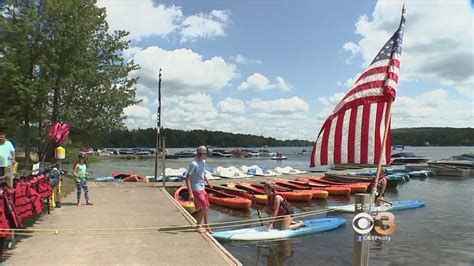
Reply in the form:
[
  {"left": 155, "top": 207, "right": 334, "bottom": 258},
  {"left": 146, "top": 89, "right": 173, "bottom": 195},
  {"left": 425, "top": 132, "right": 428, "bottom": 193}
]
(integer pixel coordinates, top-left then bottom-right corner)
[{"left": 0, "top": 209, "right": 335, "bottom": 235}]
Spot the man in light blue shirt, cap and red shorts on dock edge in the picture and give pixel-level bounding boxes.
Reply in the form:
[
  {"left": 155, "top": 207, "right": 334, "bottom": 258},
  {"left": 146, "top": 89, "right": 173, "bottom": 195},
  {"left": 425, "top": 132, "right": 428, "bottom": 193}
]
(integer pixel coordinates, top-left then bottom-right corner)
[{"left": 185, "top": 146, "right": 212, "bottom": 233}]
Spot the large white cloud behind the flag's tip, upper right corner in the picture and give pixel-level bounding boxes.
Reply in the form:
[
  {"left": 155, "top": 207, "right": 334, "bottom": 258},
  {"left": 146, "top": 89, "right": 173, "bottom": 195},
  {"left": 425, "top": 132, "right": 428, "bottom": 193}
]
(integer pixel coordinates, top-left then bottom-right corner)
[{"left": 343, "top": 0, "right": 474, "bottom": 97}]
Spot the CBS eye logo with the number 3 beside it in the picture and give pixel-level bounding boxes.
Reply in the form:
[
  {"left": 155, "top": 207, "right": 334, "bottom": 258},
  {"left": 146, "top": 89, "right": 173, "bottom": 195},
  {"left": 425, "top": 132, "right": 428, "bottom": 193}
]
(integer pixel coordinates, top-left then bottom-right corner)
[{"left": 352, "top": 212, "right": 397, "bottom": 235}]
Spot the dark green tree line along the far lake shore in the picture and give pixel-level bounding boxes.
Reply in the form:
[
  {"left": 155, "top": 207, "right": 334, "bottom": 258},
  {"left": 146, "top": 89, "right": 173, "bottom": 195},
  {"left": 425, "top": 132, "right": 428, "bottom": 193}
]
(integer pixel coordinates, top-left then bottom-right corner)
[{"left": 91, "top": 128, "right": 474, "bottom": 148}]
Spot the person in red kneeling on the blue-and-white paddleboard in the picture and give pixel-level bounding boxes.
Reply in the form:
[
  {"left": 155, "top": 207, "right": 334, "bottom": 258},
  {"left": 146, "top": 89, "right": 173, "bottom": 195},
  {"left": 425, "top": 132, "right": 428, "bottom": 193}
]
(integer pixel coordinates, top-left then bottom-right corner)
[{"left": 264, "top": 183, "right": 304, "bottom": 230}]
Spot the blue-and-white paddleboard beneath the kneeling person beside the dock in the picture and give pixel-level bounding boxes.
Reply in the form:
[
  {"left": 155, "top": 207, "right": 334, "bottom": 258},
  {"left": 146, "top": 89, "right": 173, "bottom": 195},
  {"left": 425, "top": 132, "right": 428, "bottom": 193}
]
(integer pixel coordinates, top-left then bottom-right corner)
[{"left": 212, "top": 218, "right": 346, "bottom": 241}]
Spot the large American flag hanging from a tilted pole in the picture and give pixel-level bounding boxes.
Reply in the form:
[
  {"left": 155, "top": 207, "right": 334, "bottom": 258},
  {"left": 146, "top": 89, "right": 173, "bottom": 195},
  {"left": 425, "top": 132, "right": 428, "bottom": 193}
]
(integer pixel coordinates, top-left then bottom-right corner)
[{"left": 310, "top": 9, "right": 405, "bottom": 167}]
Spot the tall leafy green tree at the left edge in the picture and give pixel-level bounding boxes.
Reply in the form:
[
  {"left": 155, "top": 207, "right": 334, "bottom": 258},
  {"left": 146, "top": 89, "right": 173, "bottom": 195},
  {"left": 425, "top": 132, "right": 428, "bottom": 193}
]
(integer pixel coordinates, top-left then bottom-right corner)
[{"left": 0, "top": 0, "right": 138, "bottom": 160}]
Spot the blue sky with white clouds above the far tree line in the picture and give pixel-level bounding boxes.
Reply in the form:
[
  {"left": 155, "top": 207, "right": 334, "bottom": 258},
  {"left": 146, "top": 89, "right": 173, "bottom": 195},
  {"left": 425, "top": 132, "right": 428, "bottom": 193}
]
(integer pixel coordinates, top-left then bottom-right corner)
[{"left": 98, "top": 0, "right": 474, "bottom": 140}]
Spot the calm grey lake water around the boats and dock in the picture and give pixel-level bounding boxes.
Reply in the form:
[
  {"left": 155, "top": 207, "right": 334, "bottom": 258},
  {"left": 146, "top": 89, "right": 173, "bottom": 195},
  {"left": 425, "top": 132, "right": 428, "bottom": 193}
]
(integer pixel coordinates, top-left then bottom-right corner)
[{"left": 90, "top": 147, "right": 474, "bottom": 265}]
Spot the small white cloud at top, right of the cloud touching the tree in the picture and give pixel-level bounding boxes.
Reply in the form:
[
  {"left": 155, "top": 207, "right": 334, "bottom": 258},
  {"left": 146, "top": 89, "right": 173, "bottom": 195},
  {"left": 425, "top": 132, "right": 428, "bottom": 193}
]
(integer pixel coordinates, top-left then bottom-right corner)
[{"left": 180, "top": 10, "right": 230, "bottom": 43}]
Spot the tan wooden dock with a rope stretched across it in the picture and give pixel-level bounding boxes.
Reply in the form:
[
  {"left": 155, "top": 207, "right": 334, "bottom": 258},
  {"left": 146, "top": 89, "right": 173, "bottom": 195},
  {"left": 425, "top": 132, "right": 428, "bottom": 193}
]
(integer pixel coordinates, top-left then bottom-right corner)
[{"left": 4, "top": 182, "right": 241, "bottom": 265}]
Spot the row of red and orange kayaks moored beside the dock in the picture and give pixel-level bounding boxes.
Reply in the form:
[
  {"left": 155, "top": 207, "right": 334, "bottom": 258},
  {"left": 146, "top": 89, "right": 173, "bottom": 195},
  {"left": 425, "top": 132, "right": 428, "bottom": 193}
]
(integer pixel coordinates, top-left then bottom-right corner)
[{"left": 174, "top": 177, "right": 370, "bottom": 213}]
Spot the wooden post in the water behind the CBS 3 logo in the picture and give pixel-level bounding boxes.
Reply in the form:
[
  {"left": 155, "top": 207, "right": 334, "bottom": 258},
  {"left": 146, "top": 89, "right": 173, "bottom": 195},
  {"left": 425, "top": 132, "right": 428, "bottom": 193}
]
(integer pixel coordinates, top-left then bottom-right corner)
[{"left": 352, "top": 193, "right": 372, "bottom": 266}]
